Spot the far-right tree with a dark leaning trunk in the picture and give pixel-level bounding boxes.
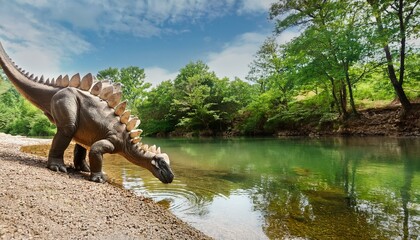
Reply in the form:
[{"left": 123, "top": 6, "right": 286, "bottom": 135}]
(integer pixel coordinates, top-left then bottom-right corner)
[{"left": 367, "top": 0, "right": 420, "bottom": 112}]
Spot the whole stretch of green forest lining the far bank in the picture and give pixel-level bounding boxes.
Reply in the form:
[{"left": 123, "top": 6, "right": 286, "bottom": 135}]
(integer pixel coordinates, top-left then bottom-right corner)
[{"left": 0, "top": 0, "right": 420, "bottom": 136}]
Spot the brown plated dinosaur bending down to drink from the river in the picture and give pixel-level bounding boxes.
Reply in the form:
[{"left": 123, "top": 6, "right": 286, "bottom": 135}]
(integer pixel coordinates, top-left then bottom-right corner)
[{"left": 0, "top": 43, "right": 174, "bottom": 183}]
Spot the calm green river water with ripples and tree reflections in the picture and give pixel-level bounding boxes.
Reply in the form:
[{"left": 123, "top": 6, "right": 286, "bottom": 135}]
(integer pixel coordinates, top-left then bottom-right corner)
[{"left": 105, "top": 138, "right": 420, "bottom": 239}]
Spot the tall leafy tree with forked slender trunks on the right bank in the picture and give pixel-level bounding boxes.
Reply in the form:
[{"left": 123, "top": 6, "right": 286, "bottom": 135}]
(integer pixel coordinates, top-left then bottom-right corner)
[{"left": 270, "top": 0, "right": 382, "bottom": 118}]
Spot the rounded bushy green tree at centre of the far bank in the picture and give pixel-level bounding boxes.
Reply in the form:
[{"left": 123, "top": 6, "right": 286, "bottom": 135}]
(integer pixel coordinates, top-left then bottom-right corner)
[{"left": 170, "top": 61, "right": 256, "bottom": 134}]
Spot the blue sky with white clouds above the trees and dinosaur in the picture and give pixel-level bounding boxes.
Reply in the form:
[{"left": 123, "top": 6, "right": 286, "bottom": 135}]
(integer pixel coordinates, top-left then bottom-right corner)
[{"left": 0, "top": 0, "right": 297, "bottom": 85}]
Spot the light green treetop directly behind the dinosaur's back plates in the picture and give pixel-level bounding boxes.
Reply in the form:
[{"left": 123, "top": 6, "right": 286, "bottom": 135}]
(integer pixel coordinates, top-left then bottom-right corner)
[{"left": 97, "top": 66, "right": 152, "bottom": 111}]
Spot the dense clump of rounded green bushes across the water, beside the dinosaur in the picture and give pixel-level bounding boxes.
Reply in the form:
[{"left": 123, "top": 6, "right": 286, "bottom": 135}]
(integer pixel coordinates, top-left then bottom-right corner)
[{"left": 138, "top": 61, "right": 257, "bottom": 135}]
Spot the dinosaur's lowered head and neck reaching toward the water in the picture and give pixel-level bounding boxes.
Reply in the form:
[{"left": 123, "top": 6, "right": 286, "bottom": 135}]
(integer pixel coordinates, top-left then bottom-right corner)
[{"left": 126, "top": 143, "right": 174, "bottom": 183}]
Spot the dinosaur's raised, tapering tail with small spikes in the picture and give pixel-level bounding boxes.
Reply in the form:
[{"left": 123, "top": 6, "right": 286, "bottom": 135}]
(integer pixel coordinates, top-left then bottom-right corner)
[{"left": 0, "top": 43, "right": 59, "bottom": 113}]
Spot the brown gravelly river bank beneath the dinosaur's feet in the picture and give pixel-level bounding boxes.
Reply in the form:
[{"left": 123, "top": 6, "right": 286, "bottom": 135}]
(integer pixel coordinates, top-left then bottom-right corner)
[{"left": 0, "top": 133, "right": 209, "bottom": 239}]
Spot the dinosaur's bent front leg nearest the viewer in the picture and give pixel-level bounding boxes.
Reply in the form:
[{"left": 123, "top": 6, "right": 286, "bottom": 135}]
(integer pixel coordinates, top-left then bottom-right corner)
[{"left": 89, "top": 139, "right": 115, "bottom": 183}]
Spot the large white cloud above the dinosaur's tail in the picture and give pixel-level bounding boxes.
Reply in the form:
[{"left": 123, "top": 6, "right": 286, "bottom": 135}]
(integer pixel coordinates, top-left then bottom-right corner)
[{"left": 0, "top": 1, "right": 90, "bottom": 77}]
